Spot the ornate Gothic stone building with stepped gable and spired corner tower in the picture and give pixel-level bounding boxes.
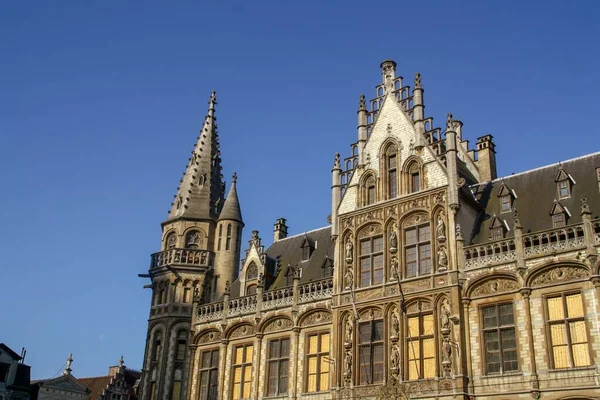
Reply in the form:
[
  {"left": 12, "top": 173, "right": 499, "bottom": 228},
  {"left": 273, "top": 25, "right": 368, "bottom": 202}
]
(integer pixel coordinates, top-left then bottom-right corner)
[{"left": 141, "top": 61, "right": 600, "bottom": 400}]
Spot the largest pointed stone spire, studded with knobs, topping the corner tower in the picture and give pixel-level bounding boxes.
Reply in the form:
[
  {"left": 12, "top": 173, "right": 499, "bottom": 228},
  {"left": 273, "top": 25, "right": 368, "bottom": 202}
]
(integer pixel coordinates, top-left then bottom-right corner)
[{"left": 168, "top": 91, "right": 224, "bottom": 220}]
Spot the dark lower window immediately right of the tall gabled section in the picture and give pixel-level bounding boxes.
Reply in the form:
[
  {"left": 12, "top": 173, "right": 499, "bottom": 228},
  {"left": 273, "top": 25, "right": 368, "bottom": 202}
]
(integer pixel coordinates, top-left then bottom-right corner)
[{"left": 482, "top": 303, "right": 519, "bottom": 374}]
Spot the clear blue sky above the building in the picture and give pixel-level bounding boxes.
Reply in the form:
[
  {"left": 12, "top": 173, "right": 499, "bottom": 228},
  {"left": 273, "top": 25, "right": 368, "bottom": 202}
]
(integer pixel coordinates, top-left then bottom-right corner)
[{"left": 0, "top": 0, "right": 600, "bottom": 378}]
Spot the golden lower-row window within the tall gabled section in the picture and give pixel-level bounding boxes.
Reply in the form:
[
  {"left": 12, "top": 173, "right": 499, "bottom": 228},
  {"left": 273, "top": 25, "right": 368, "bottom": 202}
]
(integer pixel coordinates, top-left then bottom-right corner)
[{"left": 406, "top": 313, "right": 435, "bottom": 380}]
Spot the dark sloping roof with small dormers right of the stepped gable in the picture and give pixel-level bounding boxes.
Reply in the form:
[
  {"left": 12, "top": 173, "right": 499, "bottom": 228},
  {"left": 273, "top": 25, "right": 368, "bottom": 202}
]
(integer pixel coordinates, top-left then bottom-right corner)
[{"left": 470, "top": 152, "right": 600, "bottom": 244}]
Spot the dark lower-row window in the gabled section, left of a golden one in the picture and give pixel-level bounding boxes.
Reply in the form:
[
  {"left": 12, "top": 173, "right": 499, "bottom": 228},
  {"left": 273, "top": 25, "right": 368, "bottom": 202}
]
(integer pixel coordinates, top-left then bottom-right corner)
[{"left": 358, "top": 320, "right": 383, "bottom": 385}]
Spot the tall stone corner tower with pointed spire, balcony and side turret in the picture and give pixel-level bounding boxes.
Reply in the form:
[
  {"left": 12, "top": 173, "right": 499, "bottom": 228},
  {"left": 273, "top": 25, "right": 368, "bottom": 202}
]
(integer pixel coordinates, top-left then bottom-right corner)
[{"left": 141, "top": 91, "right": 244, "bottom": 400}]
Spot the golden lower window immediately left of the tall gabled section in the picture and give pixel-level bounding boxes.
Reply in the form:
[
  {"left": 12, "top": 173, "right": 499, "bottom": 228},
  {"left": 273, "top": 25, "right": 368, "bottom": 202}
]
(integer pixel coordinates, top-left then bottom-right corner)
[{"left": 305, "top": 332, "right": 330, "bottom": 393}]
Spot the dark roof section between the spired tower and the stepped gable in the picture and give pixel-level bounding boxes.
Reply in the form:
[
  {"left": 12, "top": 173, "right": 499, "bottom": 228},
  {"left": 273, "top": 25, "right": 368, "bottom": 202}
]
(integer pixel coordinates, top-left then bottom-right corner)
[{"left": 266, "top": 226, "right": 334, "bottom": 290}]
